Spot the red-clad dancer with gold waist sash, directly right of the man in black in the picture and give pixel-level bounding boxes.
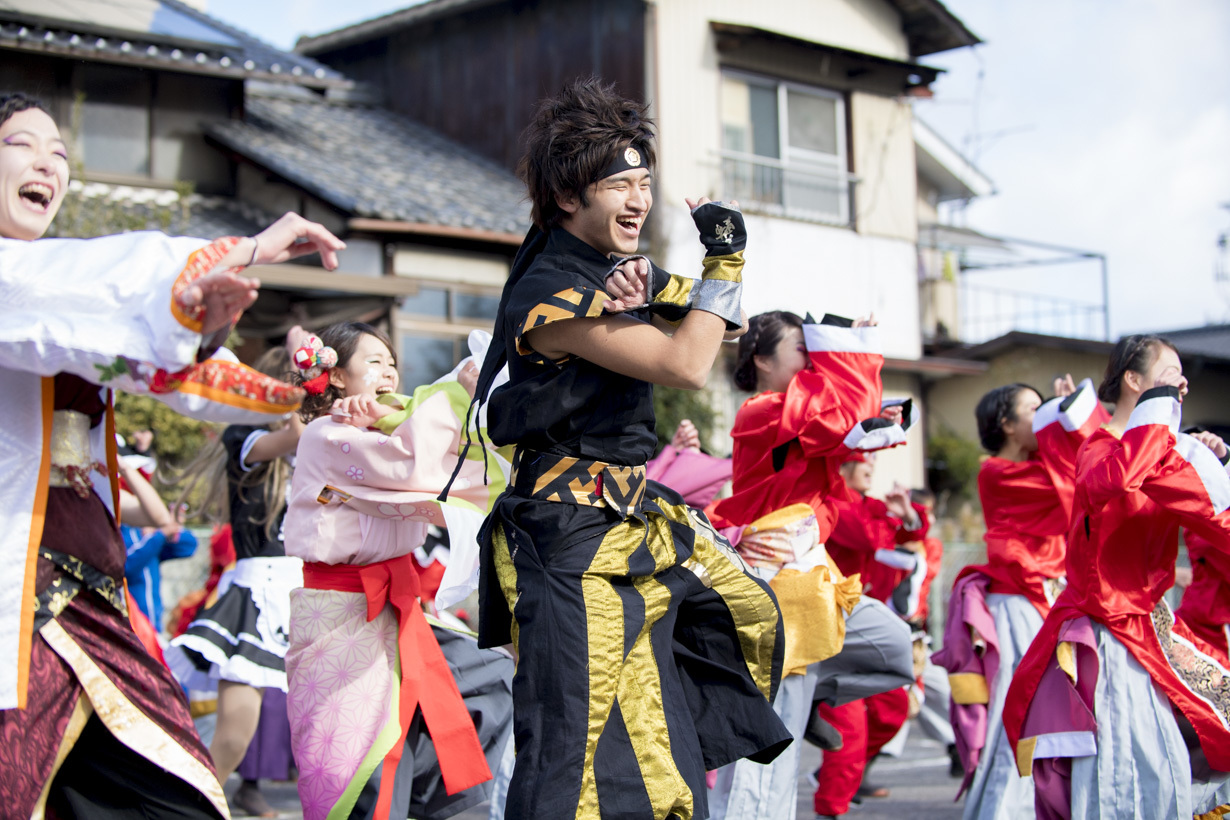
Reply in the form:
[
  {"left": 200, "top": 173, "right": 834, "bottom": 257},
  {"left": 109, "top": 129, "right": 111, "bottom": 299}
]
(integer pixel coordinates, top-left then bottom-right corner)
[{"left": 710, "top": 311, "right": 914, "bottom": 818}]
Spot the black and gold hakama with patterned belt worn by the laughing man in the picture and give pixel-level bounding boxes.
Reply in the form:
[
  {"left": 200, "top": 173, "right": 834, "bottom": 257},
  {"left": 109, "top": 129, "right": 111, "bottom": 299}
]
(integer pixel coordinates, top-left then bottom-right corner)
[{"left": 483, "top": 451, "right": 791, "bottom": 820}]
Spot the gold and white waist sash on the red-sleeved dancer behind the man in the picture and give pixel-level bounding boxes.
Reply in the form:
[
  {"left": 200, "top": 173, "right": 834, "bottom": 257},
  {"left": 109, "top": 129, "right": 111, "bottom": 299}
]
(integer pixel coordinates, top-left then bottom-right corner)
[{"left": 738, "top": 504, "right": 862, "bottom": 676}]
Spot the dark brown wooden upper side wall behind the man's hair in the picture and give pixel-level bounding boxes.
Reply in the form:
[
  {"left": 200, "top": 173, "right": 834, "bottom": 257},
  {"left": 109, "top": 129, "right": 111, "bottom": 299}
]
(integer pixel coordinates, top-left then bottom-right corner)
[{"left": 314, "top": 0, "right": 646, "bottom": 168}]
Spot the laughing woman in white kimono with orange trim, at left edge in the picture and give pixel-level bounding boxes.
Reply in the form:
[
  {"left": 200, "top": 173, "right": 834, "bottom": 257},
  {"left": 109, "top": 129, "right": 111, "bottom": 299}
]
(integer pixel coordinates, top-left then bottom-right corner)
[{"left": 0, "top": 95, "right": 343, "bottom": 818}]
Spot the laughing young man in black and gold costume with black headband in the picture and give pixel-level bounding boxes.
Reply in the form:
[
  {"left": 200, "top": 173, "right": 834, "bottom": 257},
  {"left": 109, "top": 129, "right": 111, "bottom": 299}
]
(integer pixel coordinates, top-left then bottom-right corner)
[{"left": 457, "top": 80, "right": 791, "bottom": 820}]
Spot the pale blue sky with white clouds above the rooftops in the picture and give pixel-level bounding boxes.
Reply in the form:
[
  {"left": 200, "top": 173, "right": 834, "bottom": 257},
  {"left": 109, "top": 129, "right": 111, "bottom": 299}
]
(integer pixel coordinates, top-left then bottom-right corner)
[{"left": 207, "top": 0, "right": 1230, "bottom": 334}]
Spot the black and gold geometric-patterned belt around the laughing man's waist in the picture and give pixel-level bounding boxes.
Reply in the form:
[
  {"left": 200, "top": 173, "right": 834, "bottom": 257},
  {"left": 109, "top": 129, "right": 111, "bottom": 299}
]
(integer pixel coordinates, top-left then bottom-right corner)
[{"left": 512, "top": 449, "right": 647, "bottom": 516}]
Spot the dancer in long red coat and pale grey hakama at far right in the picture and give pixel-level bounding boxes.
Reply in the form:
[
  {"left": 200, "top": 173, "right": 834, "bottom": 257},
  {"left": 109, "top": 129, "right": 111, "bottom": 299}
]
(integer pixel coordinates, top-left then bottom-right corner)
[{"left": 1004, "top": 336, "right": 1230, "bottom": 819}]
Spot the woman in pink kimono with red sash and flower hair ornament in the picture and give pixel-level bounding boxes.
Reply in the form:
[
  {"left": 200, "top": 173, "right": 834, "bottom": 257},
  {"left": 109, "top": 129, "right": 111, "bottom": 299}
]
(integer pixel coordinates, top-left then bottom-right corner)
[{"left": 285, "top": 322, "right": 513, "bottom": 820}]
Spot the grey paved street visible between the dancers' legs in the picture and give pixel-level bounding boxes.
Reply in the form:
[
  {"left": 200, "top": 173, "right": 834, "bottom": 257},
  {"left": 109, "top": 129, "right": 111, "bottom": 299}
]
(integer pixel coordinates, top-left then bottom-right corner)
[{"left": 247, "top": 727, "right": 961, "bottom": 820}]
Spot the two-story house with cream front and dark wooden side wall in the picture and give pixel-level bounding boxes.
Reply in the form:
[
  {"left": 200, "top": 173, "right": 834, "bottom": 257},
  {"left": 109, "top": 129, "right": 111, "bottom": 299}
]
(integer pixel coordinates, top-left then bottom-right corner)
[{"left": 296, "top": 0, "right": 979, "bottom": 486}]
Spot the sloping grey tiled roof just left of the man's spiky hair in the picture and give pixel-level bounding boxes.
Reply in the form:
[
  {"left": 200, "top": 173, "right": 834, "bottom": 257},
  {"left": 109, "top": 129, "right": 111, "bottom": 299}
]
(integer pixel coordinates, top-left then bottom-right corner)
[{"left": 209, "top": 93, "right": 529, "bottom": 234}]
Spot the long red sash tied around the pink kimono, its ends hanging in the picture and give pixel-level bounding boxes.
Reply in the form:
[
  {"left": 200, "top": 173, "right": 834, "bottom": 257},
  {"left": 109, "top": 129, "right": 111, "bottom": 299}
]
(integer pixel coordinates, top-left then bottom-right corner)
[{"left": 304, "top": 554, "right": 491, "bottom": 818}]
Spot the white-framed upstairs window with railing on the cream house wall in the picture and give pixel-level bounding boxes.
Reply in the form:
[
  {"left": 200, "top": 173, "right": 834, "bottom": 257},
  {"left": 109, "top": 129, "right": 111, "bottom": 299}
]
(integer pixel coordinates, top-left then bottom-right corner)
[{"left": 721, "top": 70, "right": 850, "bottom": 225}]
